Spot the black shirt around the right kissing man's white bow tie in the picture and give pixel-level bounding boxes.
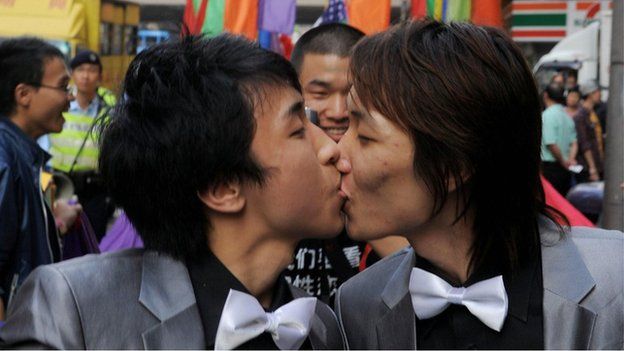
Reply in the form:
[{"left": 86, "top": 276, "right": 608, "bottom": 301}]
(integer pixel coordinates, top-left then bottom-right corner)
[{"left": 416, "top": 249, "right": 544, "bottom": 349}]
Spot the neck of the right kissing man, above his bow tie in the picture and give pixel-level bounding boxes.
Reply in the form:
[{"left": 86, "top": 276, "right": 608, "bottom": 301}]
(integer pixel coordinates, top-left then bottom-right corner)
[{"left": 406, "top": 193, "right": 474, "bottom": 284}]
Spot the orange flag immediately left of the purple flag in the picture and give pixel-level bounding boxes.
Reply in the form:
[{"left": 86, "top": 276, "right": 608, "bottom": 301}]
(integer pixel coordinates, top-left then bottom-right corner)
[{"left": 223, "top": 0, "right": 258, "bottom": 40}]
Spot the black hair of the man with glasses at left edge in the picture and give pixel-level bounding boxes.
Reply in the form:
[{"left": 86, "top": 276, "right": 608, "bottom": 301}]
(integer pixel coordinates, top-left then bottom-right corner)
[{"left": 0, "top": 37, "right": 65, "bottom": 117}]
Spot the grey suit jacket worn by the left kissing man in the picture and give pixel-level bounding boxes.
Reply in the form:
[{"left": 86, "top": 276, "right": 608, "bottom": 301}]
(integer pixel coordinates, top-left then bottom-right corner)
[{"left": 0, "top": 249, "right": 343, "bottom": 349}]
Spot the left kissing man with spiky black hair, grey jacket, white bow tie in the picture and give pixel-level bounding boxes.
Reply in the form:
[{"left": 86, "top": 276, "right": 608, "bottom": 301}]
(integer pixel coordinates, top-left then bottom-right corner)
[{"left": 0, "top": 35, "right": 344, "bottom": 349}]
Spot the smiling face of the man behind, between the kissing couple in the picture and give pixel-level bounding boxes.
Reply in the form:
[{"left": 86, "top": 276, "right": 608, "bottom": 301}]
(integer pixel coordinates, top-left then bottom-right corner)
[{"left": 299, "top": 53, "right": 350, "bottom": 142}]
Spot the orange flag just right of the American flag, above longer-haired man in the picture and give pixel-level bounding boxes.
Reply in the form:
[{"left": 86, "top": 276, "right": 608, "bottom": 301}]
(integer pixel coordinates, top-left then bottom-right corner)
[{"left": 347, "top": 0, "right": 390, "bottom": 34}]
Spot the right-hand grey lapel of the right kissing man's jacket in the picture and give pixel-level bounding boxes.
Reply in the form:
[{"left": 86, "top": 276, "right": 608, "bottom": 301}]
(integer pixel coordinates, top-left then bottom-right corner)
[{"left": 540, "top": 220, "right": 596, "bottom": 349}]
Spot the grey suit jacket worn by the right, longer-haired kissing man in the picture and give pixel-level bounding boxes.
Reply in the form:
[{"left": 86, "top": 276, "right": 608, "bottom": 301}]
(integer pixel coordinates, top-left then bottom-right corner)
[{"left": 336, "top": 220, "right": 624, "bottom": 349}]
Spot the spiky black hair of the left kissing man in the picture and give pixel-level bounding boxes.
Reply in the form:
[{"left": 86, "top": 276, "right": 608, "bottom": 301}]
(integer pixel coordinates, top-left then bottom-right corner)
[{"left": 99, "top": 34, "right": 301, "bottom": 259}]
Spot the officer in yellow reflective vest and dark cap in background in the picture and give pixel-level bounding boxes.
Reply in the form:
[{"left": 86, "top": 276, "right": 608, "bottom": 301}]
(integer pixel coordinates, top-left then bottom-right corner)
[{"left": 50, "top": 51, "right": 116, "bottom": 240}]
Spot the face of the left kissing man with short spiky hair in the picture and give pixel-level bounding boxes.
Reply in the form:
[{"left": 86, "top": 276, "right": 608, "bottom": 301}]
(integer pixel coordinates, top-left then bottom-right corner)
[{"left": 245, "top": 87, "right": 344, "bottom": 240}]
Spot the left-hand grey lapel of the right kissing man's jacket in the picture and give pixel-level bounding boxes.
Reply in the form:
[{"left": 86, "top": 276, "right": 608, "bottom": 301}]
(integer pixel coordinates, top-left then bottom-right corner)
[{"left": 376, "top": 248, "right": 416, "bottom": 350}]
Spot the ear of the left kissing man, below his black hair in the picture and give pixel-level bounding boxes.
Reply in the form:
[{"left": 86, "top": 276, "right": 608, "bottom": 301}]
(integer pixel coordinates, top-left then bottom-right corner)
[{"left": 197, "top": 182, "right": 245, "bottom": 213}]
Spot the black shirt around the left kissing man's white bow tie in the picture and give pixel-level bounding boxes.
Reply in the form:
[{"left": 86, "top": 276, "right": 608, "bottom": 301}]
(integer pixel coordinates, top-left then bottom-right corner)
[{"left": 187, "top": 251, "right": 312, "bottom": 350}]
